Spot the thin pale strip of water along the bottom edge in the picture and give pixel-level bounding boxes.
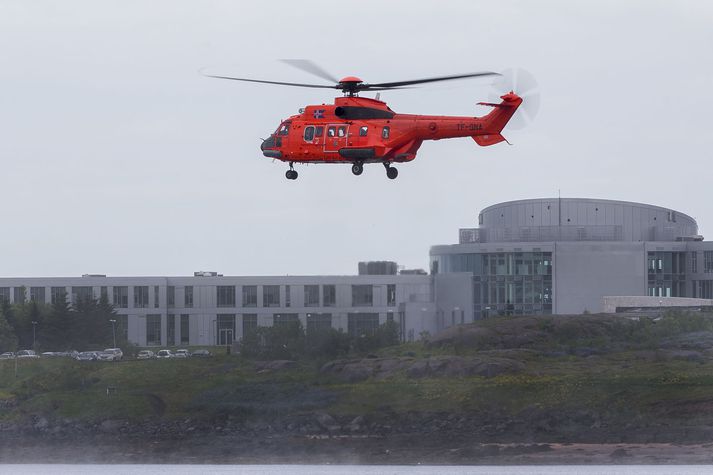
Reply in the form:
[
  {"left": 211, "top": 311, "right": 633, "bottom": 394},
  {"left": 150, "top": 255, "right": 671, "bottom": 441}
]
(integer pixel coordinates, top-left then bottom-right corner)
[{"left": 0, "top": 464, "right": 713, "bottom": 475}]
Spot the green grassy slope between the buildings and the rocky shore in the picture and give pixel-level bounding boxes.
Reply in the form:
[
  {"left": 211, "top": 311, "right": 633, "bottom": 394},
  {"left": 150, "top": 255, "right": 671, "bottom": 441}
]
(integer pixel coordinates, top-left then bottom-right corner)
[{"left": 0, "top": 317, "right": 713, "bottom": 430}]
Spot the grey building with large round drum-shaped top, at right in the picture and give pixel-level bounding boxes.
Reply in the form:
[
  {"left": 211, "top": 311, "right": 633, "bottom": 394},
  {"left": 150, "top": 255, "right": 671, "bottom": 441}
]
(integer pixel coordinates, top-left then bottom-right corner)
[{"left": 430, "top": 198, "right": 713, "bottom": 319}]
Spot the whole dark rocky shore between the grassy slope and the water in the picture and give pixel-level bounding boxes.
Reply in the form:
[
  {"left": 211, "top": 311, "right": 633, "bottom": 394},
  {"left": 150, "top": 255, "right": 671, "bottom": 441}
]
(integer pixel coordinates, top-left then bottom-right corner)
[{"left": 0, "top": 409, "right": 713, "bottom": 464}]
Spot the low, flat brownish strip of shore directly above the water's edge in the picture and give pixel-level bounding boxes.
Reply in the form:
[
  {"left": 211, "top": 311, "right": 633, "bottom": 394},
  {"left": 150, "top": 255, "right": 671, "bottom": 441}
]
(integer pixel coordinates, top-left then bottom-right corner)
[{"left": 0, "top": 434, "right": 713, "bottom": 466}]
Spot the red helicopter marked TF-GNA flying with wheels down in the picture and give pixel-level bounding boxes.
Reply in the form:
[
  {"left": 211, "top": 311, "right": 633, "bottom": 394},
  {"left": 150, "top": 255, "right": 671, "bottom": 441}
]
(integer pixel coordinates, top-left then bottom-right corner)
[{"left": 207, "top": 60, "right": 536, "bottom": 180}]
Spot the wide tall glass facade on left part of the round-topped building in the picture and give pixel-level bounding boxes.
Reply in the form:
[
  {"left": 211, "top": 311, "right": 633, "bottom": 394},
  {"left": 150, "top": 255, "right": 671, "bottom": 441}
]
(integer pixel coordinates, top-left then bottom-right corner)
[{"left": 432, "top": 251, "right": 553, "bottom": 320}]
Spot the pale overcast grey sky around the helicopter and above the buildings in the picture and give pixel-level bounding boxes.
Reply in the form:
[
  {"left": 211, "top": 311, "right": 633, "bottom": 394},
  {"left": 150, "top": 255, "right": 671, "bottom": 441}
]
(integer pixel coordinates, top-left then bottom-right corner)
[{"left": 0, "top": 0, "right": 713, "bottom": 276}]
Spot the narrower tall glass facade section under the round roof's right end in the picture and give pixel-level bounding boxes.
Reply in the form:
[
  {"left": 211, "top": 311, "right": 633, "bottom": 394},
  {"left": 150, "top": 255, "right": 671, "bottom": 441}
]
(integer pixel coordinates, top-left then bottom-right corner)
[{"left": 647, "top": 251, "right": 686, "bottom": 297}]
